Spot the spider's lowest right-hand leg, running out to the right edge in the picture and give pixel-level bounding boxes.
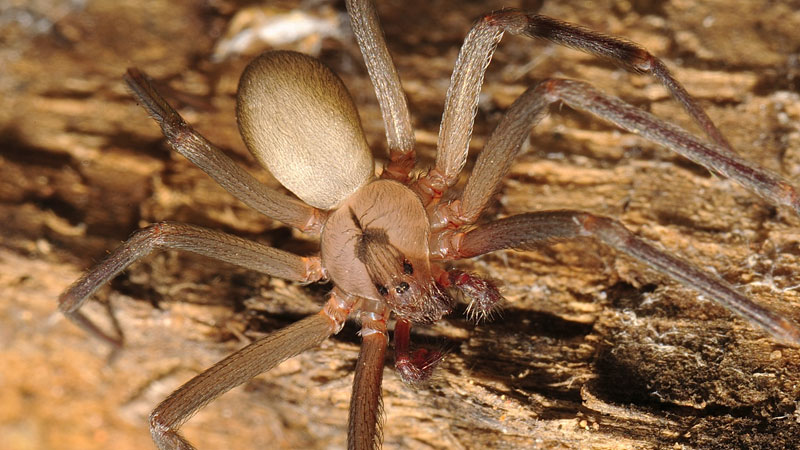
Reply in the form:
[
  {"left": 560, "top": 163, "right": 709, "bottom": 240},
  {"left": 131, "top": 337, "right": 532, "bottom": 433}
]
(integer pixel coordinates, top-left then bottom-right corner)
[{"left": 438, "top": 211, "right": 800, "bottom": 346}]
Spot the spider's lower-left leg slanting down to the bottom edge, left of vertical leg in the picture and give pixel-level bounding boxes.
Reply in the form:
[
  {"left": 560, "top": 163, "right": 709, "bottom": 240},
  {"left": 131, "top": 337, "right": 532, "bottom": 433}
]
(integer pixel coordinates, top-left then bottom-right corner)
[{"left": 150, "top": 291, "right": 355, "bottom": 450}]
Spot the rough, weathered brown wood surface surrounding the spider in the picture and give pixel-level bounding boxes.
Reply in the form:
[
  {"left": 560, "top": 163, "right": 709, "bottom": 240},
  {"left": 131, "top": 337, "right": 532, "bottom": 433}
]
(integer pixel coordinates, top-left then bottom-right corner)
[{"left": 0, "top": 0, "right": 800, "bottom": 450}]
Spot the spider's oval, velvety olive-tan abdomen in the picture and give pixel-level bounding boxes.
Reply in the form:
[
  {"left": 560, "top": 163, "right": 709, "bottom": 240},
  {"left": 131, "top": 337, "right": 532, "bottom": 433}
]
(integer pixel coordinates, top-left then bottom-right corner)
[{"left": 236, "top": 51, "right": 374, "bottom": 209}]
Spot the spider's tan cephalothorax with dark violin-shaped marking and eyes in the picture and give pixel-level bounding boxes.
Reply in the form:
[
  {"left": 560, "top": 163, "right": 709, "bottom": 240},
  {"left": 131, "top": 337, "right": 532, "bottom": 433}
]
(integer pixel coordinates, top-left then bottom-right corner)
[{"left": 320, "top": 180, "right": 451, "bottom": 323}]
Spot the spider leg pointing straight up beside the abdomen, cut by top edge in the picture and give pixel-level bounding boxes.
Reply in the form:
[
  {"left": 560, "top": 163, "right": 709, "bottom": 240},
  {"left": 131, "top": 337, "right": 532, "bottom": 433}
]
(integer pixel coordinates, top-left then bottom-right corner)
[{"left": 347, "top": 0, "right": 415, "bottom": 183}]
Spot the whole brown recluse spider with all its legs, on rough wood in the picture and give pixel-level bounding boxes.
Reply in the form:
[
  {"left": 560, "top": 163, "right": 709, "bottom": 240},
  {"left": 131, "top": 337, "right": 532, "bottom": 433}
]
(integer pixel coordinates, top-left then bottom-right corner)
[{"left": 60, "top": 0, "right": 800, "bottom": 449}]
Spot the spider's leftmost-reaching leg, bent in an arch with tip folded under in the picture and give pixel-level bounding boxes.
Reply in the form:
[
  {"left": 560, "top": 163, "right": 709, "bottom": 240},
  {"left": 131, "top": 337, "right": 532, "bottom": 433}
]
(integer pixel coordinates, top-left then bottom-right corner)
[{"left": 58, "top": 222, "right": 325, "bottom": 347}]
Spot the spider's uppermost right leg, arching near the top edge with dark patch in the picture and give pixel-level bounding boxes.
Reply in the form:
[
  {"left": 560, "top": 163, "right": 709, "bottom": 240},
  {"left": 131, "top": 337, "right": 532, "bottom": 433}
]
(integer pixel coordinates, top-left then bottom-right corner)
[{"left": 418, "top": 9, "right": 732, "bottom": 200}]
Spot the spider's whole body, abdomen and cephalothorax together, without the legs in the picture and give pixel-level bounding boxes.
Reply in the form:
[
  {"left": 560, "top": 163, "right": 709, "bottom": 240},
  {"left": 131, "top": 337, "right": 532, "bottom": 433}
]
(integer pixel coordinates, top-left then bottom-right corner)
[{"left": 237, "top": 52, "right": 450, "bottom": 323}]
